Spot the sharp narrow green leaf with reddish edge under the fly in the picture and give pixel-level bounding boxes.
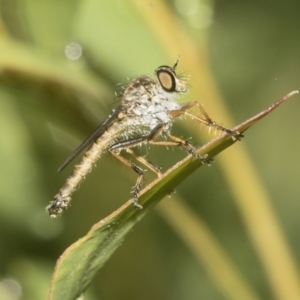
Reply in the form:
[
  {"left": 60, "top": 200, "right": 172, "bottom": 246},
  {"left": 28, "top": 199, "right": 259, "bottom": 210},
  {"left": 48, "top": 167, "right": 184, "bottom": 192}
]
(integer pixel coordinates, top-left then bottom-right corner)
[{"left": 48, "top": 91, "right": 298, "bottom": 300}]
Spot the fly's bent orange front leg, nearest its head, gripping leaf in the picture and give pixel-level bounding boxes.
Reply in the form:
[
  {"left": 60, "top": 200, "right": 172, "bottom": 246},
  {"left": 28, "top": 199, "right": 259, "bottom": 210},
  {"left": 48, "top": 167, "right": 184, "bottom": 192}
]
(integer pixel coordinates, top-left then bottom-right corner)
[{"left": 170, "top": 101, "right": 243, "bottom": 141}]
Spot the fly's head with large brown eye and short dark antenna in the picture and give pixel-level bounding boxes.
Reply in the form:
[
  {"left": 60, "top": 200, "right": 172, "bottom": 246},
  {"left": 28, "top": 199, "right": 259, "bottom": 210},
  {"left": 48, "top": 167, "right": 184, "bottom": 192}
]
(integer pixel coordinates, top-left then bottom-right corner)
[{"left": 155, "top": 61, "right": 188, "bottom": 93}]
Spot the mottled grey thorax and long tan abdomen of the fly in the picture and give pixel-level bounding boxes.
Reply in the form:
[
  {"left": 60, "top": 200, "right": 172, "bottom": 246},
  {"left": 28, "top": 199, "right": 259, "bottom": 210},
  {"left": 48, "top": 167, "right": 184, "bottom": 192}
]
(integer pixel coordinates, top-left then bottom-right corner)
[{"left": 47, "top": 64, "right": 187, "bottom": 217}]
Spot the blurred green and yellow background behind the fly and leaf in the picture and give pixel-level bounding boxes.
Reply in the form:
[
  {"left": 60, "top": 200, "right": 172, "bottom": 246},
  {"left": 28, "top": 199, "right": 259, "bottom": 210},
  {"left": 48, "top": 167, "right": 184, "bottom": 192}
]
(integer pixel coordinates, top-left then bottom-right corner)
[{"left": 0, "top": 0, "right": 300, "bottom": 300}]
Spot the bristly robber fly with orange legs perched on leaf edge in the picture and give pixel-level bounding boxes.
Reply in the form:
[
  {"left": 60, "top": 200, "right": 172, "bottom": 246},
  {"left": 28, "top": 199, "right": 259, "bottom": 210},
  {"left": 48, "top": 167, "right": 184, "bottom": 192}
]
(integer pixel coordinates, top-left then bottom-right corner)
[{"left": 47, "top": 61, "right": 241, "bottom": 217}]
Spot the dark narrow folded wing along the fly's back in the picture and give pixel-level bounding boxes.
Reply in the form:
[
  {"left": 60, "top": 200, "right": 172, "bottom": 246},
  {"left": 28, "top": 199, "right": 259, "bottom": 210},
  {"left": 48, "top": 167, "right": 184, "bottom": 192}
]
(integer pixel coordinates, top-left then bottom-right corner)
[{"left": 57, "top": 106, "right": 122, "bottom": 172}]
